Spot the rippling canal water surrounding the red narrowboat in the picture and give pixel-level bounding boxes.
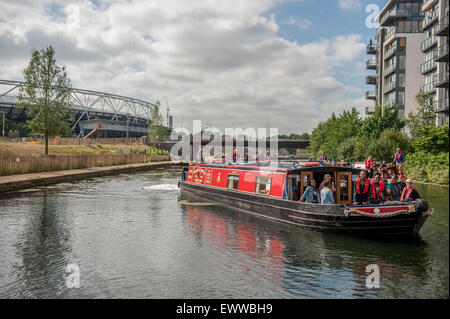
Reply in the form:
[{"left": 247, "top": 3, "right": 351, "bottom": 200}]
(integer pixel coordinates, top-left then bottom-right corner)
[{"left": 0, "top": 169, "right": 449, "bottom": 298}]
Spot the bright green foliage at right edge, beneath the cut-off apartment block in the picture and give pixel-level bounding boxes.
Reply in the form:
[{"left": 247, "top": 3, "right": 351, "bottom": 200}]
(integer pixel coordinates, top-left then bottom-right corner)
[{"left": 412, "top": 124, "right": 449, "bottom": 155}]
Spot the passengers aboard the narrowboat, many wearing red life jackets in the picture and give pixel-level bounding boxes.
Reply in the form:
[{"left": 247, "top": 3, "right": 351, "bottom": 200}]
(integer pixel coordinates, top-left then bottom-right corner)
[{"left": 300, "top": 148, "right": 420, "bottom": 205}]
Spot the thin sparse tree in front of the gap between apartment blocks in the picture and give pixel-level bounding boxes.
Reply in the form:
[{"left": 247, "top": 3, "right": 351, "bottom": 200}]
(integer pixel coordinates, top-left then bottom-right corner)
[{"left": 406, "top": 89, "right": 436, "bottom": 137}]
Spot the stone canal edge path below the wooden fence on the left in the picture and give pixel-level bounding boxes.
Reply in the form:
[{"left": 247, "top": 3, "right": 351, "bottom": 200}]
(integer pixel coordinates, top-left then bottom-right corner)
[{"left": 0, "top": 161, "right": 182, "bottom": 193}]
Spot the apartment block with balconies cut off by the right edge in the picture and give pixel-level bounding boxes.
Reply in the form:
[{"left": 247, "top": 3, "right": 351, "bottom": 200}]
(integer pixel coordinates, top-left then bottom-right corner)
[{"left": 420, "top": 0, "right": 449, "bottom": 125}]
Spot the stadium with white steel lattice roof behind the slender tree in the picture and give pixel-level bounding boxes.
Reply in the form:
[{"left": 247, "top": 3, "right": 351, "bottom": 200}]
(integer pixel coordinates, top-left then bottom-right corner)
[{"left": 0, "top": 79, "right": 167, "bottom": 137}]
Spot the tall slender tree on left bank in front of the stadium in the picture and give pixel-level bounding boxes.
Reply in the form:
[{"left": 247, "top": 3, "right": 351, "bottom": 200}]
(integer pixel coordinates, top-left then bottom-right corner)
[{"left": 18, "top": 46, "right": 72, "bottom": 155}]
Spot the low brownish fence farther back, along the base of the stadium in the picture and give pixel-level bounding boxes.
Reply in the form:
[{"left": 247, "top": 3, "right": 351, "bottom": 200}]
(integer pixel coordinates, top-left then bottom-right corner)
[{"left": 0, "top": 136, "right": 147, "bottom": 145}]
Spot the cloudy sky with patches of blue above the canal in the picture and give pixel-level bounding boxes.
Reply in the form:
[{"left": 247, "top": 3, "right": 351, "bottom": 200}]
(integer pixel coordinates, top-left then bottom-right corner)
[{"left": 0, "top": 0, "right": 386, "bottom": 133}]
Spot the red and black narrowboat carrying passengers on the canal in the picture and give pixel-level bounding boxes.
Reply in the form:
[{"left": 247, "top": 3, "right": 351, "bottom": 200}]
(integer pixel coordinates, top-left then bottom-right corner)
[{"left": 180, "top": 162, "right": 432, "bottom": 237}]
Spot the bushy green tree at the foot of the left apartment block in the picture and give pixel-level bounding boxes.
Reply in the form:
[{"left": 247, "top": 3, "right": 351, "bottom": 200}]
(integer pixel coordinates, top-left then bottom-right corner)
[{"left": 358, "top": 105, "right": 405, "bottom": 138}]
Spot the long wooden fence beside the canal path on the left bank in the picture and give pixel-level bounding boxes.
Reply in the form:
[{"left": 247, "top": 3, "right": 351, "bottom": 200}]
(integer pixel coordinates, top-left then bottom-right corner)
[{"left": 0, "top": 154, "right": 169, "bottom": 176}]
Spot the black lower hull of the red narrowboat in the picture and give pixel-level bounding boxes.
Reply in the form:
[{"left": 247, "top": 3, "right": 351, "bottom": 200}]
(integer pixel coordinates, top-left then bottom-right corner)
[{"left": 180, "top": 181, "right": 427, "bottom": 237}]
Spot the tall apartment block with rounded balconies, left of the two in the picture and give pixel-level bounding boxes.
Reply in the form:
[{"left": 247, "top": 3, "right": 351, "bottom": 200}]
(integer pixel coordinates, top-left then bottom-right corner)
[{"left": 366, "top": 0, "right": 424, "bottom": 119}]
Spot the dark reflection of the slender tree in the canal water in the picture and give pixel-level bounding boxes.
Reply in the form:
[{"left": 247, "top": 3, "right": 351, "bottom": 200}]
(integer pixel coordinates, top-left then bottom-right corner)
[{"left": 15, "top": 191, "right": 71, "bottom": 298}]
